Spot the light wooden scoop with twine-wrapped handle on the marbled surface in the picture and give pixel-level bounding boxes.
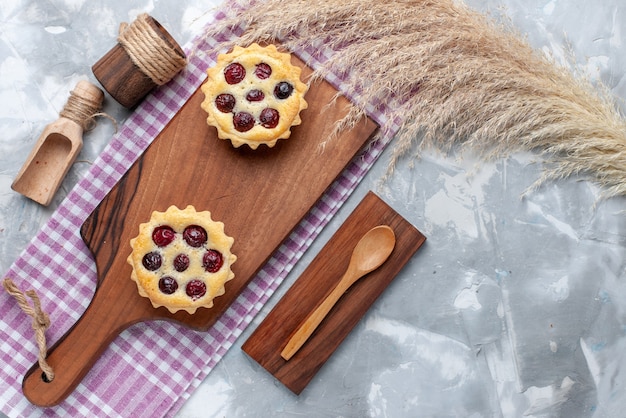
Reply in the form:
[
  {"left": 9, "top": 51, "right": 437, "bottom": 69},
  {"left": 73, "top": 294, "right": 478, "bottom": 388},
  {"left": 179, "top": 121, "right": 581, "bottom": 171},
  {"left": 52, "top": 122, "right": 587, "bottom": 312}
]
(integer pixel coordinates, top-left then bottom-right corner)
[{"left": 11, "top": 81, "right": 104, "bottom": 206}]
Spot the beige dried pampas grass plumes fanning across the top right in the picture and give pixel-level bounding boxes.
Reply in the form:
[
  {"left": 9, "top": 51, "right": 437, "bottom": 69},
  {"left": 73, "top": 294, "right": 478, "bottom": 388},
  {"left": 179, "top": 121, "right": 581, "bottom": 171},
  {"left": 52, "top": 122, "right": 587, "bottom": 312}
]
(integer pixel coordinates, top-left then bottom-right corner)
[{"left": 207, "top": 0, "right": 626, "bottom": 197}]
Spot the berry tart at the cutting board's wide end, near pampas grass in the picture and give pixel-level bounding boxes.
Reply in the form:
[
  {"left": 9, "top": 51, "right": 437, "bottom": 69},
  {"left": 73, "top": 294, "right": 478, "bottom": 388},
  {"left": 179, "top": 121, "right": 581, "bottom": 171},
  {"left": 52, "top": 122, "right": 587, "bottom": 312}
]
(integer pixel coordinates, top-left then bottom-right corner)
[{"left": 202, "top": 44, "right": 308, "bottom": 149}]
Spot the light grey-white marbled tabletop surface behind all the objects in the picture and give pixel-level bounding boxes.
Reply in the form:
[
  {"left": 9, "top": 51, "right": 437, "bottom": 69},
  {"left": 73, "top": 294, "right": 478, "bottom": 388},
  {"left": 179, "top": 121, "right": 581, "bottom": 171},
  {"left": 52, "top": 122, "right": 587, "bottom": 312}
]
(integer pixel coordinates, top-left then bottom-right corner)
[{"left": 0, "top": 0, "right": 626, "bottom": 418}]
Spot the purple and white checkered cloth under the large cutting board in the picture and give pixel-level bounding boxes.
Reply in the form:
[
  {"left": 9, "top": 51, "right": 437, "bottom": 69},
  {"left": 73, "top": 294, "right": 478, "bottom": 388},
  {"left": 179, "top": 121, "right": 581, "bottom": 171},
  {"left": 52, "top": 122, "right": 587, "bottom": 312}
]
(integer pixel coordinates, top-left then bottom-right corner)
[{"left": 0, "top": 3, "right": 397, "bottom": 417}]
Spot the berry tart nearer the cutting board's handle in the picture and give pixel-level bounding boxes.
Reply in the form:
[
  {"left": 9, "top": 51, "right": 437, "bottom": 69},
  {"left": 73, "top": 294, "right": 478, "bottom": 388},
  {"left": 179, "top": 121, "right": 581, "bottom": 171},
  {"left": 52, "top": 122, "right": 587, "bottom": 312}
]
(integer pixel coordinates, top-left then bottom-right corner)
[{"left": 128, "top": 205, "right": 237, "bottom": 314}]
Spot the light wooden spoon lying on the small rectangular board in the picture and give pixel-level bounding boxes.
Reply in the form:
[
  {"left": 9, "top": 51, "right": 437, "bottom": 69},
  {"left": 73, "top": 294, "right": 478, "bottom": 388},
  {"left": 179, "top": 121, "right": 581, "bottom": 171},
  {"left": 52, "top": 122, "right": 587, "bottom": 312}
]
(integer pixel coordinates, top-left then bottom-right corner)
[{"left": 280, "top": 225, "right": 396, "bottom": 360}]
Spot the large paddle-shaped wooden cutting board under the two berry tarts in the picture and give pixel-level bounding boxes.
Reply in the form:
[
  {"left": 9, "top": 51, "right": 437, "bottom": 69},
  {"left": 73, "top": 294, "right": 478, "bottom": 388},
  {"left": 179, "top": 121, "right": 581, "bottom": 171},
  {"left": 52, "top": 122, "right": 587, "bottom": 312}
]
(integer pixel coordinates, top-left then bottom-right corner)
[{"left": 23, "top": 50, "right": 377, "bottom": 406}]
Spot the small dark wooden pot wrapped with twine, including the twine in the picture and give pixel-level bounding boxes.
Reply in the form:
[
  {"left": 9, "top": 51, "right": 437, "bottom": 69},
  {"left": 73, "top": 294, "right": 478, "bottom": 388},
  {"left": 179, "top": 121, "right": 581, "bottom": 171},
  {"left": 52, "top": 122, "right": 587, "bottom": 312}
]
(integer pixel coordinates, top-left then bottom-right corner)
[{"left": 91, "top": 13, "right": 187, "bottom": 108}]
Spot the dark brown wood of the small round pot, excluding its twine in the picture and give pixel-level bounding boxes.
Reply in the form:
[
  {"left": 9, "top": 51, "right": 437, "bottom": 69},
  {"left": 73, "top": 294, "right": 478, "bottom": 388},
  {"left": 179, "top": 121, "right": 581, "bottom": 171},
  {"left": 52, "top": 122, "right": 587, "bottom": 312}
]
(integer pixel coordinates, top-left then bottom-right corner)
[{"left": 91, "top": 16, "right": 185, "bottom": 108}]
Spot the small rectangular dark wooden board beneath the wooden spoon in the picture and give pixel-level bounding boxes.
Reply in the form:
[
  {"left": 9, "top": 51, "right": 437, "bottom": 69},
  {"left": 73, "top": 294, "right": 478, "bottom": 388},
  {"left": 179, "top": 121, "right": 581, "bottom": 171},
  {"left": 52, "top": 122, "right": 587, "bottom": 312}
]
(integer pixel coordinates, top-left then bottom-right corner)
[{"left": 242, "top": 192, "right": 426, "bottom": 394}]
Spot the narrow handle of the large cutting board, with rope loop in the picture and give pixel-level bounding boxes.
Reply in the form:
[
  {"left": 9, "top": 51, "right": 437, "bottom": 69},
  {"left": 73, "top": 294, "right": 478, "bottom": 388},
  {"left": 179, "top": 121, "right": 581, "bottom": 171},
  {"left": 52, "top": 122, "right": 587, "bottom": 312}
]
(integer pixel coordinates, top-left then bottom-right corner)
[{"left": 22, "top": 278, "right": 141, "bottom": 407}]
